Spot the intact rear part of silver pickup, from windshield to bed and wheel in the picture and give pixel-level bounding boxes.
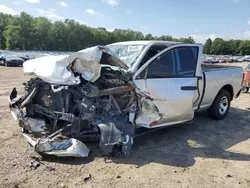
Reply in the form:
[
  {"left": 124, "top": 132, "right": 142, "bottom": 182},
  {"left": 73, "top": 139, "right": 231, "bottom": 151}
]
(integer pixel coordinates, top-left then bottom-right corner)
[{"left": 108, "top": 41, "right": 242, "bottom": 128}]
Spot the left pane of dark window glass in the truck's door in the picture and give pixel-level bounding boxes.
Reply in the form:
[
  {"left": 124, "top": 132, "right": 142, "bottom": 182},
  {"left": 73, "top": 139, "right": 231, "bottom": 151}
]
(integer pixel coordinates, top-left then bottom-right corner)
[{"left": 147, "top": 51, "right": 175, "bottom": 78}]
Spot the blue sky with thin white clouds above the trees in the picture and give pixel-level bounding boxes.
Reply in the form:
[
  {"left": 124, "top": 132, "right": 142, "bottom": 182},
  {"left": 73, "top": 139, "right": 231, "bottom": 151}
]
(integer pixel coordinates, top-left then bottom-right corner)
[{"left": 0, "top": 0, "right": 250, "bottom": 42}]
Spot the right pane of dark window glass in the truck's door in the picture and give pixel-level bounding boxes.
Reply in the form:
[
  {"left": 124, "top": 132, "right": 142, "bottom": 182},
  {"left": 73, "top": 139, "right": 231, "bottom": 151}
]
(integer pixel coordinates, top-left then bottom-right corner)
[{"left": 174, "top": 47, "right": 198, "bottom": 77}]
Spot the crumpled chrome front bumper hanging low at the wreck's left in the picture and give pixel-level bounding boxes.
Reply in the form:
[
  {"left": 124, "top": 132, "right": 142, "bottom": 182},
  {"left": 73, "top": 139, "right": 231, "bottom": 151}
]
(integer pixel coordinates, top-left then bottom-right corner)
[{"left": 9, "top": 97, "right": 89, "bottom": 157}]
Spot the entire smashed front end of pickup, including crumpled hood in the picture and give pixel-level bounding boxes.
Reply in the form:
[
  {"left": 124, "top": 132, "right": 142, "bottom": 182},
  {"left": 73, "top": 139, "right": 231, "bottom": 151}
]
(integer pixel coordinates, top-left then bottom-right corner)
[{"left": 9, "top": 46, "right": 161, "bottom": 157}]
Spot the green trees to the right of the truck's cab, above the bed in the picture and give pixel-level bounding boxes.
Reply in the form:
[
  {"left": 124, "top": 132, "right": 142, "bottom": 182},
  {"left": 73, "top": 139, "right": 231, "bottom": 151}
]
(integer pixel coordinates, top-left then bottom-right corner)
[{"left": 203, "top": 38, "right": 250, "bottom": 55}]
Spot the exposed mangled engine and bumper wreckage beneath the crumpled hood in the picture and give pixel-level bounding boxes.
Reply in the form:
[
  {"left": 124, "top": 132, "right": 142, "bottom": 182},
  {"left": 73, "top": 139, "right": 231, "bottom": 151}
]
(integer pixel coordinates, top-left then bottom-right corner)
[{"left": 8, "top": 73, "right": 135, "bottom": 157}]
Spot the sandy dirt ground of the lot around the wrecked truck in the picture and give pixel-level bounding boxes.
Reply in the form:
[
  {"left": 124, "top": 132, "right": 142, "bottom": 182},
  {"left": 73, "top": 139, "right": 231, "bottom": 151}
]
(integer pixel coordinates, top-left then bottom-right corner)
[{"left": 0, "top": 63, "right": 250, "bottom": 188}]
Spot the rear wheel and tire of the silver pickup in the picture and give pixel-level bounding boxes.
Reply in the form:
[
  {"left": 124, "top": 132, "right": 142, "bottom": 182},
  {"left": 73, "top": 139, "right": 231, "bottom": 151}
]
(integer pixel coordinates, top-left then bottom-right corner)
[{"left": 208, "top": 89, "right": 232, "bottom": 120}]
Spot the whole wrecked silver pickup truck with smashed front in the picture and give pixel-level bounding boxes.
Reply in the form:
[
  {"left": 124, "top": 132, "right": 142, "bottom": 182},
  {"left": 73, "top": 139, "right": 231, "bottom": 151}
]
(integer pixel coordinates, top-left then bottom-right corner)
[{"left": 9, "top": 41, "right": 243, "bottom": 157}]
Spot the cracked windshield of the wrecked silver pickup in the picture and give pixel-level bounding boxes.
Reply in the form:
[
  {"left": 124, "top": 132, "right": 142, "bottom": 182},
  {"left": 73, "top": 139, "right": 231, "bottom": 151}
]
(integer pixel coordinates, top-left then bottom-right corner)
[{"left": 108, "top": 44, "right": 146, "bottom": 67}]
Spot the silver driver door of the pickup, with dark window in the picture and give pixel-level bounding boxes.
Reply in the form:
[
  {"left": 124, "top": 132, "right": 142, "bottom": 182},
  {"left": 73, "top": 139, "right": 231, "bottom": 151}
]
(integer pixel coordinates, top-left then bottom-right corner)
[{"left": 134, "top": 44, "right": 201, "bottom": 128}]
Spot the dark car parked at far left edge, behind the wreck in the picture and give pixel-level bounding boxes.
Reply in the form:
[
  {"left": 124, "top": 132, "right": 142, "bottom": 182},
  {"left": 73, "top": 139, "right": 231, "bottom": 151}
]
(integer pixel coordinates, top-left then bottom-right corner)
[{"left": 0, "top": 54, "right": 24, "bottom": 67}]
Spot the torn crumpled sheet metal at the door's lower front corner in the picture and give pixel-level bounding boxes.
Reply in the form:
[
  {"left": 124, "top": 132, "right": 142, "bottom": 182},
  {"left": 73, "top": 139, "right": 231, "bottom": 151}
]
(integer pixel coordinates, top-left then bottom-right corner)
[{"left": 136, "top": 97, "right": 162, "bottom": 128}]
